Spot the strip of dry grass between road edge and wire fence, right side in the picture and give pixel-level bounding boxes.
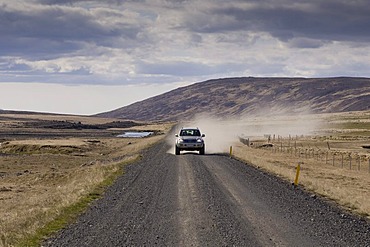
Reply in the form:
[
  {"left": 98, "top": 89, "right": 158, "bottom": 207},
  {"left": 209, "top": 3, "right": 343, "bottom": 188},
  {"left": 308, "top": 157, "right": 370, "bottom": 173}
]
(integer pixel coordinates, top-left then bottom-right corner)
[{"left": 234, "top": 144, "right": 370, "bottom": 216}]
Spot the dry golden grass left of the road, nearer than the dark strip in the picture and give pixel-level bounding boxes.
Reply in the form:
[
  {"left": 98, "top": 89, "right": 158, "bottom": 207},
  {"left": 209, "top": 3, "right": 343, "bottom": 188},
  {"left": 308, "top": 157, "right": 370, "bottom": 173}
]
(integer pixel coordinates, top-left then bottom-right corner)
[{"left": 0, "top": 116, "right": 170, "bottom": 246}]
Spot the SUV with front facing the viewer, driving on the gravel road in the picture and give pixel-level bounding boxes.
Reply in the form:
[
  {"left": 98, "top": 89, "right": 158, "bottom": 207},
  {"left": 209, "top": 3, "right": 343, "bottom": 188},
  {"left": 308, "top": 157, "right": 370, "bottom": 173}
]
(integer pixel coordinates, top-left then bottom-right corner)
[{"left": 175, "top": 128, "right": 206, "bottom": 155}]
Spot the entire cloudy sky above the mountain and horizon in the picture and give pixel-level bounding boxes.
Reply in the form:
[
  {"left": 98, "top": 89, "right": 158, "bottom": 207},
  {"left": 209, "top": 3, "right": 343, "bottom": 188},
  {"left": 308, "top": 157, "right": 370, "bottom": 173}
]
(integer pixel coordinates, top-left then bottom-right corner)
[{"left": 0, "top": 0, "right": 370, "bottom": 115}]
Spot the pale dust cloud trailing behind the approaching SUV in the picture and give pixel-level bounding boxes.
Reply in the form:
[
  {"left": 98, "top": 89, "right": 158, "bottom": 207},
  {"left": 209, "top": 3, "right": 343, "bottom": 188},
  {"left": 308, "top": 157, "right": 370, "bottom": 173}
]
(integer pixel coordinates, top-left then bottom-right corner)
[{"left": 168, "top": 112, "right": 323, "bottom": 154}]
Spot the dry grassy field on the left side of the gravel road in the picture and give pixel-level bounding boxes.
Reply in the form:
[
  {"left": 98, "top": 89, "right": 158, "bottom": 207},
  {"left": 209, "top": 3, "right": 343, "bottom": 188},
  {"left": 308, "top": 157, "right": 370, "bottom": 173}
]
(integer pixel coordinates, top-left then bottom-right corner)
[{"left": 0, "top": 115, "right": 170, "bottom": 246}]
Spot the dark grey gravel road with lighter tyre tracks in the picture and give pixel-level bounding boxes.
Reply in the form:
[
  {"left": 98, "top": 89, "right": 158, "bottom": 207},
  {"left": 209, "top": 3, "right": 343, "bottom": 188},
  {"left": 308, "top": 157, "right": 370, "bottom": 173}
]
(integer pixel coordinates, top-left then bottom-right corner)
[{"left": 44, "top": 142, "right": 370, "bottom": 246}]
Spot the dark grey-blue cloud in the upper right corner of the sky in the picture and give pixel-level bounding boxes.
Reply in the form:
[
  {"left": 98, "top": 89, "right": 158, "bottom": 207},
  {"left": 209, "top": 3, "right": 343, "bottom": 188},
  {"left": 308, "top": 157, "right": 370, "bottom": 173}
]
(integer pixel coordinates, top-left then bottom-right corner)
[{"left": 185, "top": 0, "right": 370, "bottom": 42}]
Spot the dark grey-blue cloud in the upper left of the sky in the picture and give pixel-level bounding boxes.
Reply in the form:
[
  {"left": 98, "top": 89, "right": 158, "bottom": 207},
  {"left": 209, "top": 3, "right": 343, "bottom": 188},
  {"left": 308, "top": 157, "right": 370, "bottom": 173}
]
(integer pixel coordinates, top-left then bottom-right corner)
[{"left": 0, "top": 1, "right": 140, "bottom": 57}]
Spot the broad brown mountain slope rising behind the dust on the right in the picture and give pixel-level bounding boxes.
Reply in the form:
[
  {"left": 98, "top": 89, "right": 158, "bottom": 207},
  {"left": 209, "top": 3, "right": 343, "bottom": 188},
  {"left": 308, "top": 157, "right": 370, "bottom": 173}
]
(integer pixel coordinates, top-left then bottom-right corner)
[{"left": 96, "top": 77, "right": 370, "bottom": 121}]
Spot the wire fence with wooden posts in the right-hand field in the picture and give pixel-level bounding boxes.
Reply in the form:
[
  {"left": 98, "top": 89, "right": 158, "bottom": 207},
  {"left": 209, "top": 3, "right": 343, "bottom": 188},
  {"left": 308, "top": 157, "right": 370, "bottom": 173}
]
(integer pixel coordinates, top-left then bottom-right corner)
[{"left": 239, "top": 136, "right": 370, "bottom": 173}]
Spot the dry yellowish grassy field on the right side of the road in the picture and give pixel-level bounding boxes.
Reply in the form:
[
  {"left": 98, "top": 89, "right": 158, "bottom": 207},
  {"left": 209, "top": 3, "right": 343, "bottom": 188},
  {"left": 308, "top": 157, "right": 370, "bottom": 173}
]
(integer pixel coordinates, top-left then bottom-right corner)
[{"left": 234, "top": 111, "right": 370, "bottom": 218}]
